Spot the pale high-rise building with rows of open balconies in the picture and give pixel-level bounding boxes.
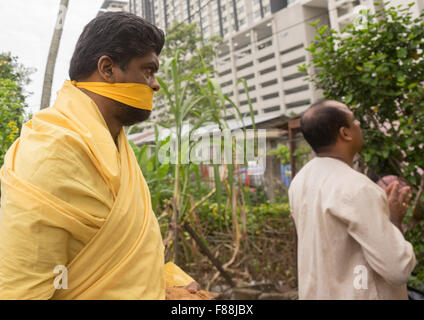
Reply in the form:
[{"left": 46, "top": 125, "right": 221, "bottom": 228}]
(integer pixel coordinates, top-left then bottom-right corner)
[{"left": 129, "top": 0, "right": 424, "bottom": 132}]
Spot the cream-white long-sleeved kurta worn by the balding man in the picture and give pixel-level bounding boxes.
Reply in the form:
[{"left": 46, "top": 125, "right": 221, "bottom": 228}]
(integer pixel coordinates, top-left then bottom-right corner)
[{"left": 289, "top": 157, "right": 416, "bottom": 299}]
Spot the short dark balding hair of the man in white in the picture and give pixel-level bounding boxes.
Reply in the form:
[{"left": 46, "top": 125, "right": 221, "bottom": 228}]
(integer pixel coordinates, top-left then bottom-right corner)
[{"left": 300, "top": 100, "right": 349, "bottom": 153}]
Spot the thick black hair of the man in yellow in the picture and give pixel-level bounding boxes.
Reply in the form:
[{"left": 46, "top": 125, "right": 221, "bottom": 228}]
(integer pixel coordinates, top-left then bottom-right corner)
[{"left": 69, "top": 12, "right": 165, "bottom": 81}]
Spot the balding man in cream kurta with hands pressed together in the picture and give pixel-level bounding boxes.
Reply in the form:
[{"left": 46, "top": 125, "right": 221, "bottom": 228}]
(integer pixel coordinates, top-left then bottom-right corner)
[{"left": 289, "top": 100, "right": 416, "bottom": 300}]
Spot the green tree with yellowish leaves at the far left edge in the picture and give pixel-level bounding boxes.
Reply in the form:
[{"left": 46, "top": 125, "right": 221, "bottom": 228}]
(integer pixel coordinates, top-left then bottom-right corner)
[{"left": 0, "top": 53, "right": 31, "bottom": 166}]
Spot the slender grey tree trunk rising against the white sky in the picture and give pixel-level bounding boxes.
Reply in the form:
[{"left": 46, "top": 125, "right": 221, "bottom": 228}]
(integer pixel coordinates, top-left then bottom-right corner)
[{"left": 40, "top": 0, "right": 69, "bottom": 109}]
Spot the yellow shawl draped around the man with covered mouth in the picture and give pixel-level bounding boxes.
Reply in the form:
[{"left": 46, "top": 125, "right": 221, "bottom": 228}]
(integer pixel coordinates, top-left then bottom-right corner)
[{"left": 0, "top": 82, "right": 165, "bottom": 299}]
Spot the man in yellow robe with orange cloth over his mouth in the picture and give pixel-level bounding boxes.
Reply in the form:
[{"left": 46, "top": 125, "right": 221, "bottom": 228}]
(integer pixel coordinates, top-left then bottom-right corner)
[{"left": 0, "top": 13, "right": 195, "bottom": 299}]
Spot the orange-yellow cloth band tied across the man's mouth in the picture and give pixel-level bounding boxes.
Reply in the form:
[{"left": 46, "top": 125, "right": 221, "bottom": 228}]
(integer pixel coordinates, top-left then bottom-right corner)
[{"left": 70, "top": 81, "right": 153, "bottom": 111}]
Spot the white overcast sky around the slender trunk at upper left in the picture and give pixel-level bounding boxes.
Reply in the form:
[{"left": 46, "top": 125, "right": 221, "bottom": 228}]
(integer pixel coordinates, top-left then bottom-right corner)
[{"left": 0, "top": 0, "right": 103, "bottom": 112}]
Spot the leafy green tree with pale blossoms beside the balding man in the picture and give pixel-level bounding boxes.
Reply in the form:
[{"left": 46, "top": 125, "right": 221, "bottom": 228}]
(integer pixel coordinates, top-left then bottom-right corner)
[{"left": 300, "top": 3, "right": 424, "bottom": 283}]
